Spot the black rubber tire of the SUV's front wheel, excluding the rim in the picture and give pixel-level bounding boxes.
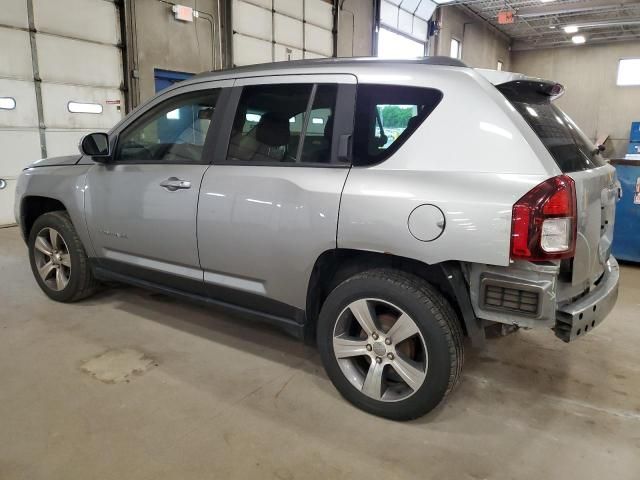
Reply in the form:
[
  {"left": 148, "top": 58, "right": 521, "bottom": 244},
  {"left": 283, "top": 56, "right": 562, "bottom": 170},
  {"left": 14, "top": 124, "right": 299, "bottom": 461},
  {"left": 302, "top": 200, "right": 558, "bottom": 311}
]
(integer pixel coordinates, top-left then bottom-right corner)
[{"left": 28, "top": 211, "right": 98, "bottom": 303}]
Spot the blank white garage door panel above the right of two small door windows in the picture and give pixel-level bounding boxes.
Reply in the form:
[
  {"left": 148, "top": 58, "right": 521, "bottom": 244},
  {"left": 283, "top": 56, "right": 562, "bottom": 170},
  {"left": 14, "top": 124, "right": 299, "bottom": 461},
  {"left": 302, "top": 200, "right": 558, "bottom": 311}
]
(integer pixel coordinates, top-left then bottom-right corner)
[{"left": 36, "top": 34, "right": 123, "bottom": 88}]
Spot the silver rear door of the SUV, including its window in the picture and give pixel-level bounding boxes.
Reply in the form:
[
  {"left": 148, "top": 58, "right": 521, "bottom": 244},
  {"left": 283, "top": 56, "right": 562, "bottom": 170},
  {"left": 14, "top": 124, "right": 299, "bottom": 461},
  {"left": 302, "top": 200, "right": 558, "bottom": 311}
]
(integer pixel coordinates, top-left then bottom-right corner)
[{"left": 198, "top": 75, "right": 356, "bottom": 317}]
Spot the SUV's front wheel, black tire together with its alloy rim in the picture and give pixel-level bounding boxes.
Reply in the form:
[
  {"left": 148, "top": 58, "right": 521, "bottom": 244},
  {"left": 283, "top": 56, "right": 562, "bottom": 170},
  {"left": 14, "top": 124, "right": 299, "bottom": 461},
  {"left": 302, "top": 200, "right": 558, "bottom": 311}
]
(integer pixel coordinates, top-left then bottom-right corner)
[{"left": 27, "top": 211, "right": 98, "bottom": 303}]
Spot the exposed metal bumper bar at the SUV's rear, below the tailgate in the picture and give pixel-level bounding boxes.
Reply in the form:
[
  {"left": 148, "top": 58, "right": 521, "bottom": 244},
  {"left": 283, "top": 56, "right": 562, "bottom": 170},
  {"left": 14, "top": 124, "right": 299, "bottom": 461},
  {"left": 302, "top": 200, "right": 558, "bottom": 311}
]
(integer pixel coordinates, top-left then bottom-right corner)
[{"left": 554, "top": 256, "right": 620, "bottom": 342}]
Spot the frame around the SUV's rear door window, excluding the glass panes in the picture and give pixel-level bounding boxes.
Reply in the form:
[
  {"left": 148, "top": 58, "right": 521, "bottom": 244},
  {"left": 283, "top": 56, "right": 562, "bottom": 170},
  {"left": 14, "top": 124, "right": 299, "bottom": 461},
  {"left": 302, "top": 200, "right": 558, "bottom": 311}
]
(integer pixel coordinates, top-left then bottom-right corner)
[{"left": 213, "top": 78, "right": 356, "bottom": 168}]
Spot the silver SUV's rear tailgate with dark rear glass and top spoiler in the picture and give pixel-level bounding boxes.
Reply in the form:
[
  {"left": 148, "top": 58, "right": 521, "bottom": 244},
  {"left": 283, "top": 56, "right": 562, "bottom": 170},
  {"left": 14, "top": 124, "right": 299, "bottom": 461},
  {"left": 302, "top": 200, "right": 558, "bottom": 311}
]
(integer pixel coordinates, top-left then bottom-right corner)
[{"left": 497, "top": 79, "right": 617, "bottom": 296}]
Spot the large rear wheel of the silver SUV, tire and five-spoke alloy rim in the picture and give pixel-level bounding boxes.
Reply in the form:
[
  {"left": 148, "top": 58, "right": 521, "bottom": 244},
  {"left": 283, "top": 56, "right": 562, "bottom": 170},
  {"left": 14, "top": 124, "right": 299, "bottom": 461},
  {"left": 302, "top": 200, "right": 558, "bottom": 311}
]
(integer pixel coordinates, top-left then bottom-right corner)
[{"left": 317, "top": 269, "right": 464, "bottom": 420}]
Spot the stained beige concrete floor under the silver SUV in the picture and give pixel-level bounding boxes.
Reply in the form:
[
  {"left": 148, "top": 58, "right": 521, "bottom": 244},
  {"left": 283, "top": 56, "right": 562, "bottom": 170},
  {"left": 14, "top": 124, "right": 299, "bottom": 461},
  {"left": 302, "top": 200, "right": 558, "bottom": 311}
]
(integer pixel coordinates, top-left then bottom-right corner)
[{"left": 0, "top": 228, "right": 640, "bottom": 480}]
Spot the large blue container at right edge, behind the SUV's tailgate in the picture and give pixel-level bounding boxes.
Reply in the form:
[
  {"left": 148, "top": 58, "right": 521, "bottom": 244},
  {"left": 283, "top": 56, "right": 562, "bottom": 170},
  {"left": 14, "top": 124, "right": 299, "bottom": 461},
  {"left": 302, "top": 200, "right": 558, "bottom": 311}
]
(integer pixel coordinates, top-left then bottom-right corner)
[{"left": 611, "top": 160, "right": 640, "bottom": 262}]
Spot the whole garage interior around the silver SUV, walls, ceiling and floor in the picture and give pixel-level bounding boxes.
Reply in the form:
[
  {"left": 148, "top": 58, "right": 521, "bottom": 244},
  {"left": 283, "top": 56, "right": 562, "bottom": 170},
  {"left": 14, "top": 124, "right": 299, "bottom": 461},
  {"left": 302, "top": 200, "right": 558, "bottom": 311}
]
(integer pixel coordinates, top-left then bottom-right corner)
[{"left": 0, "top": 0, "right": 640, "bottom": 480}]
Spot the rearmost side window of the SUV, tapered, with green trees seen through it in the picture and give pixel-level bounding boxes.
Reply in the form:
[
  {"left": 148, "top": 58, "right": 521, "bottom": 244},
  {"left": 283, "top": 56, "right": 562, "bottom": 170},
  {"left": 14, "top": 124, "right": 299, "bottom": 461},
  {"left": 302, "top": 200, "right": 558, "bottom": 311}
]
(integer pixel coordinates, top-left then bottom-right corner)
[{"left": 353, "top": 84, "right": 442, "bottom": 165}]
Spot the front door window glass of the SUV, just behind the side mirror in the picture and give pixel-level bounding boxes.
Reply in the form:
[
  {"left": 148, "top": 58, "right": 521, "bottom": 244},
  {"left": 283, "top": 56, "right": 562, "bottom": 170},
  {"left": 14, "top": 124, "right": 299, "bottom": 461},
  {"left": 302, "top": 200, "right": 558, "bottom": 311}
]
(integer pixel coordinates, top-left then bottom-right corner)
[{"left": 116, "top": 90, "right": 220, "bottom": 163}]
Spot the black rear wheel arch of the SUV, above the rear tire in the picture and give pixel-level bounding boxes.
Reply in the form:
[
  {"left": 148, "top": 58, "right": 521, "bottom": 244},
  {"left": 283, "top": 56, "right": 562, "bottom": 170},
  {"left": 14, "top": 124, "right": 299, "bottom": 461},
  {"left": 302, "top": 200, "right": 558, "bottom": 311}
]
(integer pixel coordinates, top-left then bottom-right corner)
[{"left": 305, "top": 248, "right": 485, "bottom": 346}]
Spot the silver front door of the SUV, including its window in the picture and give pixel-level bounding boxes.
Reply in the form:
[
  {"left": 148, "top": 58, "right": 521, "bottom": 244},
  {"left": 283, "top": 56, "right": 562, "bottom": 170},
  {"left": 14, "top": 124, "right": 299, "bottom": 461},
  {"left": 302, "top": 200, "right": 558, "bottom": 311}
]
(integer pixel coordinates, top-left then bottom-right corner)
[{"left": 86, "top": 85, "right": 229, "bottom": 290}]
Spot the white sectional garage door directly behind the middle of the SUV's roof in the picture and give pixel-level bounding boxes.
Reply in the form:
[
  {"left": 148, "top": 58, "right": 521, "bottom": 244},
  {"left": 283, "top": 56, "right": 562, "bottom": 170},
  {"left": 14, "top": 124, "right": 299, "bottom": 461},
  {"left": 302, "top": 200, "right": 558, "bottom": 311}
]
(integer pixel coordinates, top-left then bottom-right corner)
[{"left": 231, "top": 0, "right": 333, "bottom": 65}]
